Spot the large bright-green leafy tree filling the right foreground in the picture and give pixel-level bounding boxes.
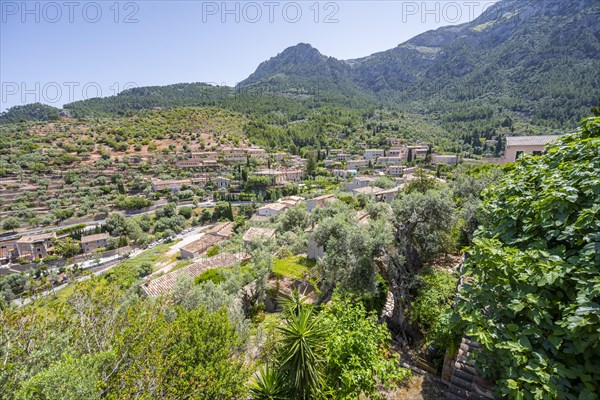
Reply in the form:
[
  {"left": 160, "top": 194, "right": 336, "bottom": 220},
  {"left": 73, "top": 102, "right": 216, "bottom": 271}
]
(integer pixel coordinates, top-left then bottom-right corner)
[{"left": 458, "top": 117, "right": 600, "bottom": 399}]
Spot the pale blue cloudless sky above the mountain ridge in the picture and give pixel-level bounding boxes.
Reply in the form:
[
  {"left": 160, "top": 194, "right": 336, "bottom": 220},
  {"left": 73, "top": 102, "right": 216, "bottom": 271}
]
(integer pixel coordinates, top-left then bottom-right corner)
[{"left": 0, "top": 0, "right": 495, "bottom": 111}]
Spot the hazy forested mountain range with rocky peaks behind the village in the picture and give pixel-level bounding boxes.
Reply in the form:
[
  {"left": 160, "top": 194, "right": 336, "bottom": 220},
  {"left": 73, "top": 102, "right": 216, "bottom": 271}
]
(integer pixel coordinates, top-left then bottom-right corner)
[{"left": 0, "top": 0, "right": 600, "bottom": 128}]
